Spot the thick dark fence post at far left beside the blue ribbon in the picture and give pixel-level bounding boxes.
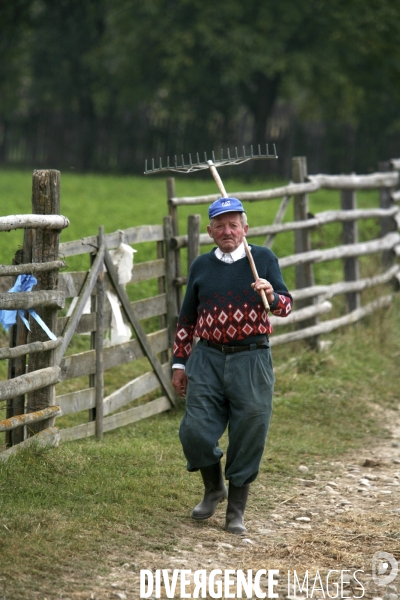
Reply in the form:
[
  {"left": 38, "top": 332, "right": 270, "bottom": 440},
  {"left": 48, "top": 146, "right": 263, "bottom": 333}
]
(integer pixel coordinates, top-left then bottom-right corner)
[{"left": 27, "top": 169, "right": 60, "bottom": 435}]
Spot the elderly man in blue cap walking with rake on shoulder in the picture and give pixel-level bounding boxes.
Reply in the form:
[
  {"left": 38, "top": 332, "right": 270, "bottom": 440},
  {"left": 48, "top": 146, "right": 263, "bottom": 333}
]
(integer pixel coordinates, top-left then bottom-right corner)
[{"left": 172, "top": 198, "right": 292, "bottom": 534}]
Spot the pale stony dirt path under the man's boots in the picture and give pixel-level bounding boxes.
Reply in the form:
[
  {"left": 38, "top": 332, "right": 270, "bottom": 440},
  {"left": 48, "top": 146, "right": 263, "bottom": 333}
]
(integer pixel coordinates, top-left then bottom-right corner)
[{"left": 63, "top": 412, "right": 400, "bottom": 600}]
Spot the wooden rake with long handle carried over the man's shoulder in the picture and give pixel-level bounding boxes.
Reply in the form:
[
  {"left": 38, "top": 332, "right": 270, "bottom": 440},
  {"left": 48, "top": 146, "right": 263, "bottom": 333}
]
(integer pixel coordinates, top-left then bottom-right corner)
[{"left": 144, "top": 144, "right": 278, "bottom": 311}]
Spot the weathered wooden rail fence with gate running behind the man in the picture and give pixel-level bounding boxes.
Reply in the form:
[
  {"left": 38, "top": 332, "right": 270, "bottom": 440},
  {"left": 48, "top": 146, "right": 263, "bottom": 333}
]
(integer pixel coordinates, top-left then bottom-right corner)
[{"left": 0, "top": 157, "right": 400, "bottom": 460}]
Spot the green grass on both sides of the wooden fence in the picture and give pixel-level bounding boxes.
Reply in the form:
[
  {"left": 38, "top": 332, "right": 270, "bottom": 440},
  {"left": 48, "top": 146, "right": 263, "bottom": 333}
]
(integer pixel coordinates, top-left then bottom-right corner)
[{"left": 0, "top": 171, "right": 400, "bottom": 600}]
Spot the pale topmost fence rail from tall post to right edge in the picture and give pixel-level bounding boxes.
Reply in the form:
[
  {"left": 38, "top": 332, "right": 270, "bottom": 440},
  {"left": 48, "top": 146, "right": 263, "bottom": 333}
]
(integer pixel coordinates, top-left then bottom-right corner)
[{"left": 308, "top": 171, "right": 399, "bottom": 190}]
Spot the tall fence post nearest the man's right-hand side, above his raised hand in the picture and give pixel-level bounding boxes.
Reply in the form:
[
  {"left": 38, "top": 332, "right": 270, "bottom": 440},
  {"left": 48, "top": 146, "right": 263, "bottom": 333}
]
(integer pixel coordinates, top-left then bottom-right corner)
[{"left": 292, "top": 156, "right": 319, "bottom": 347}]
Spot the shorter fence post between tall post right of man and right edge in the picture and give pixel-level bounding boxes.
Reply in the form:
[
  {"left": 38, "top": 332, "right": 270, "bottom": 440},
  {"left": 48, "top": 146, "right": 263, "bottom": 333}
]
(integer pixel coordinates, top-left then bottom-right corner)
[{"left": 340, "top": 190, "right": 361, "bottom": 312}]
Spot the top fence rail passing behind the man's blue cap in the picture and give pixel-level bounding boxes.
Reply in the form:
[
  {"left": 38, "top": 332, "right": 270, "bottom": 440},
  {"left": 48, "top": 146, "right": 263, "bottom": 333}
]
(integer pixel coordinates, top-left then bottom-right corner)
[{"left": 169, "top": 181, "right": 319, "bottom": 206}]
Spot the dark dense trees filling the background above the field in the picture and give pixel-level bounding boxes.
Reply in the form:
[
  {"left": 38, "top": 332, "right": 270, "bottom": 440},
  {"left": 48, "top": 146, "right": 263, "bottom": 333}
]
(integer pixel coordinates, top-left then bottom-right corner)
[{"left": 0, "top": 0, "right": 400, "bottom": 171}]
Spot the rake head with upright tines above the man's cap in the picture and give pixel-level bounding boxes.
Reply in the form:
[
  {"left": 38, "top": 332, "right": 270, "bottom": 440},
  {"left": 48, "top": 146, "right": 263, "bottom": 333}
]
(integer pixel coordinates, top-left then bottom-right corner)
[{"left": 144, "top": 144, "right": 278, "bottom": 175}]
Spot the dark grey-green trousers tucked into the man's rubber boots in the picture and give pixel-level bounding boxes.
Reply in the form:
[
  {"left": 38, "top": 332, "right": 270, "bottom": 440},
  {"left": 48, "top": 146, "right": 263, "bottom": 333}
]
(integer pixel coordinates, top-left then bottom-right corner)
[{"left": 179, "top": 342, "right": 274, "bottom": 487}]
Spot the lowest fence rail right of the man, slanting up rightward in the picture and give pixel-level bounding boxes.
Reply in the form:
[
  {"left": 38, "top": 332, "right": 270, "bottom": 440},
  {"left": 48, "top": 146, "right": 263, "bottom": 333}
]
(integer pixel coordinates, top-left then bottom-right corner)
[{"left": 270, "top": 296, "right": 392, "bottom": 346}]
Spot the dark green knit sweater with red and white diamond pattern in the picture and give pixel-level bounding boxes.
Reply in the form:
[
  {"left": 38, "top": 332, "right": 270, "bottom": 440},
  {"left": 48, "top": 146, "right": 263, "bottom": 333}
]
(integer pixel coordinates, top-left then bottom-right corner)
[{"left": 172, "top": 245, "right": 293, "bottom": 365}]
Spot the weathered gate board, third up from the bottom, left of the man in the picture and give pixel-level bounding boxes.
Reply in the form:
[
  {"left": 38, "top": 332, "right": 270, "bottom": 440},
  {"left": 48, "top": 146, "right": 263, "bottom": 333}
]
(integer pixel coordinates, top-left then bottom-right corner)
[{"left": 60, "top": 329, "right": 169, "bottom": 381}]
